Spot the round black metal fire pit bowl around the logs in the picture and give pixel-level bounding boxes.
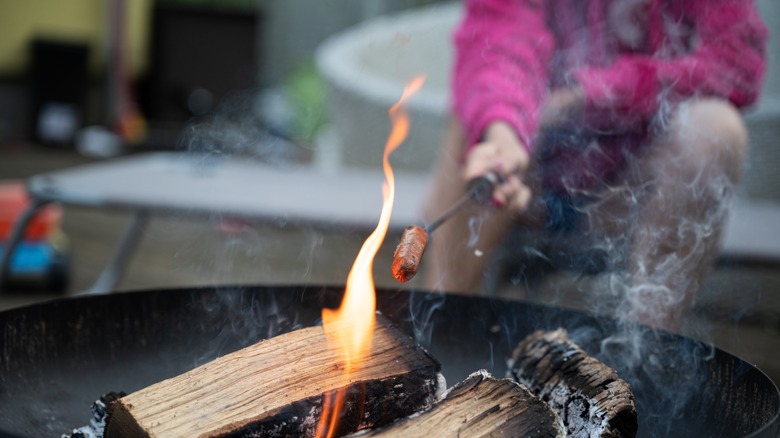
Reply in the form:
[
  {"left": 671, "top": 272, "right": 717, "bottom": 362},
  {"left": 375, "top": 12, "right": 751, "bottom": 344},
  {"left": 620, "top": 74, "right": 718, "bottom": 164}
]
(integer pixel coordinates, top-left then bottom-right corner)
[{"left": 0, "top": 286, "right": 780, "bottom": 437}]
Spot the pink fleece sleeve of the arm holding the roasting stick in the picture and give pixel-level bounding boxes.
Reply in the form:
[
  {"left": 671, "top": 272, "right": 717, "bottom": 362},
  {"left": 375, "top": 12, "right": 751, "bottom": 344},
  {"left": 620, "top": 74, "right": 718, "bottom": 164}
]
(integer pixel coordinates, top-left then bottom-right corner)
[{"left": 453, "top": 0, "right": 554, "bottom": 151}]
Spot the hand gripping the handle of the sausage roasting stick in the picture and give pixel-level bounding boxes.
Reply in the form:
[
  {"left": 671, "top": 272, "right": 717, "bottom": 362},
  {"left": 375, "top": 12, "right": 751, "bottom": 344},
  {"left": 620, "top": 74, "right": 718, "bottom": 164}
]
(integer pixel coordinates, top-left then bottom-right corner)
[{"left": 462, "top": 122, "right": 531, "bottom": 213}]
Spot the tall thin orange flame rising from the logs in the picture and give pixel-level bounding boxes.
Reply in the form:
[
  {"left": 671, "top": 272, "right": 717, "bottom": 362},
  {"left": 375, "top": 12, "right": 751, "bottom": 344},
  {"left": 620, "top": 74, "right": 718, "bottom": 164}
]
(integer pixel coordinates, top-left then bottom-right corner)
[{"left": 316, "top": 76, "right": 425, "bottom": 438}]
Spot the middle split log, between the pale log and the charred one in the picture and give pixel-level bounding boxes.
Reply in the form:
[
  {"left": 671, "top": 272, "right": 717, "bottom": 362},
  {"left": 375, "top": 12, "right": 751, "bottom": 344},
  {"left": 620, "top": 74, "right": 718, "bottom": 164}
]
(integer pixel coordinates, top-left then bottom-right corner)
[{"left": 353, "top": 371, "right": 565, "bottom": 438}]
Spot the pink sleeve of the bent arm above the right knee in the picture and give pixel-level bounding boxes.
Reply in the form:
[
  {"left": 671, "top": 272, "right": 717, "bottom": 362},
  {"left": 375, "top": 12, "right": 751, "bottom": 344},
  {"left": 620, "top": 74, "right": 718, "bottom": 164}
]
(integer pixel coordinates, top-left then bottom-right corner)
[{"left": 574, "top": 0, "right": 767, "bottom": 125}]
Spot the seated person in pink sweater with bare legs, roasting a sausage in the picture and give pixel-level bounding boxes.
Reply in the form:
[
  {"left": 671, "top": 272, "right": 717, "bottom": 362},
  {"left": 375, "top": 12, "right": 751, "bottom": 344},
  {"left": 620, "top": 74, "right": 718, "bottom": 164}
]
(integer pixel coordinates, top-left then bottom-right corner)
[{"left": 424, "top": 0, "right": 767, "bottom": 330}]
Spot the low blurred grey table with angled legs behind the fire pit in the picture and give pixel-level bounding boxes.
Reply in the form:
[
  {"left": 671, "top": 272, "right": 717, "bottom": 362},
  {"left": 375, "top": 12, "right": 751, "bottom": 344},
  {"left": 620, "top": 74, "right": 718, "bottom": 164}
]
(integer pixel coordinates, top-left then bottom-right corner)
[{"left": 0, "top": 152, "right": 427, "bottom": 293}]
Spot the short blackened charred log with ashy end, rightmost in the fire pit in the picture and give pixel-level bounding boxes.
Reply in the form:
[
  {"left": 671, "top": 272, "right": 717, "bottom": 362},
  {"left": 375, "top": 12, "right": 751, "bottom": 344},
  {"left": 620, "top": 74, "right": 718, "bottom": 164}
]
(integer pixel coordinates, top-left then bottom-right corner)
[{"left": 509, "top": 329, "right": 637, "bottom": 437}]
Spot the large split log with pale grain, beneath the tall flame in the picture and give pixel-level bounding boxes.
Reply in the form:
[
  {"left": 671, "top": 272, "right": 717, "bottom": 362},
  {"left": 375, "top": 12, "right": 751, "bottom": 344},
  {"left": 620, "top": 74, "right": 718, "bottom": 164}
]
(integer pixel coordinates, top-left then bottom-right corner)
[{"left": 105, "top": 315, "right": 444, "bottom": 438}]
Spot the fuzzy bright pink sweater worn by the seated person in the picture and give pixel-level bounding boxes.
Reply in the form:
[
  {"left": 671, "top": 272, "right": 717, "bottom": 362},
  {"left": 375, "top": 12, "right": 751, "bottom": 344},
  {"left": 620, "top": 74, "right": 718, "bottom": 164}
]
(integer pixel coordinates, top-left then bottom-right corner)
[{"left": 453, "top": 0, "right": 767, "bottom": 150}]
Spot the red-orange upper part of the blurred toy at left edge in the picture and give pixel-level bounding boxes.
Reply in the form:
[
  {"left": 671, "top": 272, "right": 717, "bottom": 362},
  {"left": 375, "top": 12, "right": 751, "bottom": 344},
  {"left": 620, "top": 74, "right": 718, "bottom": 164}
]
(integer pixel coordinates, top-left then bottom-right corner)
[{"left": 0, "top": 180, "right": 62, "bottom": 241}]
